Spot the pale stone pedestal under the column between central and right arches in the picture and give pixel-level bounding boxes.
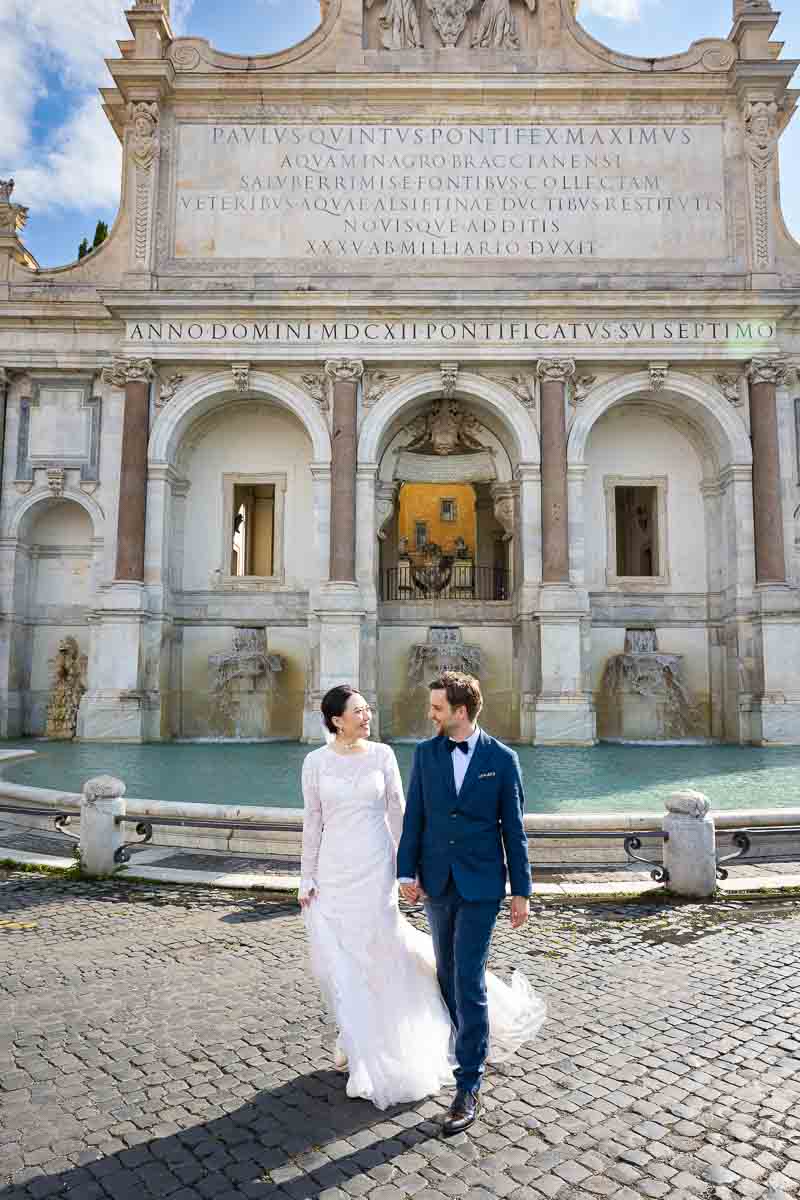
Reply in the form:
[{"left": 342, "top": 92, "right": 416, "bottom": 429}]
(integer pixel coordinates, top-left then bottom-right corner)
[{"left": 534, "top": 584, "right": 597, "bottom": 745}]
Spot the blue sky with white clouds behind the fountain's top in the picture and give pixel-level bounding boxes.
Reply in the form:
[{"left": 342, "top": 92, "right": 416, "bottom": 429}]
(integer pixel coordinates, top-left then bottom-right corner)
[{"left": 0, "top": 0, "right": 800, "bottom": 266}]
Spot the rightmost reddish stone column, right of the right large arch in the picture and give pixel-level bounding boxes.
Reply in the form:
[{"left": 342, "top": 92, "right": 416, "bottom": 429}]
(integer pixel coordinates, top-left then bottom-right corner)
[{"left": 747, "top": 359, "right": 787, "bottom": 583}]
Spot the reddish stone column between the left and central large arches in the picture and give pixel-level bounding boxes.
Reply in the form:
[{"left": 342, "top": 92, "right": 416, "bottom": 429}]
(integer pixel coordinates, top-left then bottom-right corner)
[{"left": 325, "top": 359, "right": 363, "bottom": 583}]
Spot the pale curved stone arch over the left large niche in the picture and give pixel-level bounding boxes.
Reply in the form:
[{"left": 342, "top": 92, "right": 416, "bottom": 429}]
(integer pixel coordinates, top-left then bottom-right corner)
[{"left": 148, "top": 371, "right": 331, "bottom": 467}]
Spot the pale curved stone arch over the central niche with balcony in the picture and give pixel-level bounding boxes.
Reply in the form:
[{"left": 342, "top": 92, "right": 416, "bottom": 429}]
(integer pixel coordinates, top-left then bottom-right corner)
[{"left": 359, "top": 371, "right": 540, "bottom": 466}]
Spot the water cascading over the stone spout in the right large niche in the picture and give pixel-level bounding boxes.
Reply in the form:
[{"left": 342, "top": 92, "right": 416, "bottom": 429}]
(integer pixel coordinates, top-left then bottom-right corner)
[{"left": 597, "top": 628, "right": 705, "bottom": 742}]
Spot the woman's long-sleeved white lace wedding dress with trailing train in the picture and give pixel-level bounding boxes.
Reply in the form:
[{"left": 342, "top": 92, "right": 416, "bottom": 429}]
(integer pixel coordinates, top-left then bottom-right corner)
[{"left": 300, "top": 742, "right": 546, "bottom": 1109}]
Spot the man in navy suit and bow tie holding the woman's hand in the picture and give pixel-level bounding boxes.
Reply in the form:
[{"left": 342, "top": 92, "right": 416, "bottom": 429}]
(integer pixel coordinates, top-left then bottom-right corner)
[{"left": 397, "top": 671, "right": 531, "bottom": 1135}]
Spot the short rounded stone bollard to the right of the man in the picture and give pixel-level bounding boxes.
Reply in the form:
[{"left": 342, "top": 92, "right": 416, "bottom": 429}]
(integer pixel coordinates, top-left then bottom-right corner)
[{"left": 663, "top": 791, "right": 717, "bottom": 900}]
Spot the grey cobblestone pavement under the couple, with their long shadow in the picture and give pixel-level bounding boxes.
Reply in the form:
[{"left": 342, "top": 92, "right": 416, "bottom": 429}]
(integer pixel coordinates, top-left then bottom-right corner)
[{"left": 0, "top": 874, "right": 800, "bottom": 1200}]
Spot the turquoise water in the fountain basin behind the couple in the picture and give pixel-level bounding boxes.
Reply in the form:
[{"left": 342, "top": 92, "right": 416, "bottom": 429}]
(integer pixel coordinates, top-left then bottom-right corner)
[{"left": 0, "top": 740, "right": 800, "bottom": 812}]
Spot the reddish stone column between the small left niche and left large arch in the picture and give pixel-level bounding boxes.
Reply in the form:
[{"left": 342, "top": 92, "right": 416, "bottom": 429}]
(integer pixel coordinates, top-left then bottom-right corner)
[{"left": 103, "top": 359, "right": 154, "bottom": 583}]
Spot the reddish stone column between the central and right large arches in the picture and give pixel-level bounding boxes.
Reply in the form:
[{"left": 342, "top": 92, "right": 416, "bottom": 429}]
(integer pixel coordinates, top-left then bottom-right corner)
[{"left": 536, "top": 359, "right": 575, "bottom": 583}]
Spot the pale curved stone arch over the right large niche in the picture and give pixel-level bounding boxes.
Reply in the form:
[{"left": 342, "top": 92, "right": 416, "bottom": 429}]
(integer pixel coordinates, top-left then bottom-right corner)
[{"left": 567, "top": 371, "right": 753, "bottom": 473}]
